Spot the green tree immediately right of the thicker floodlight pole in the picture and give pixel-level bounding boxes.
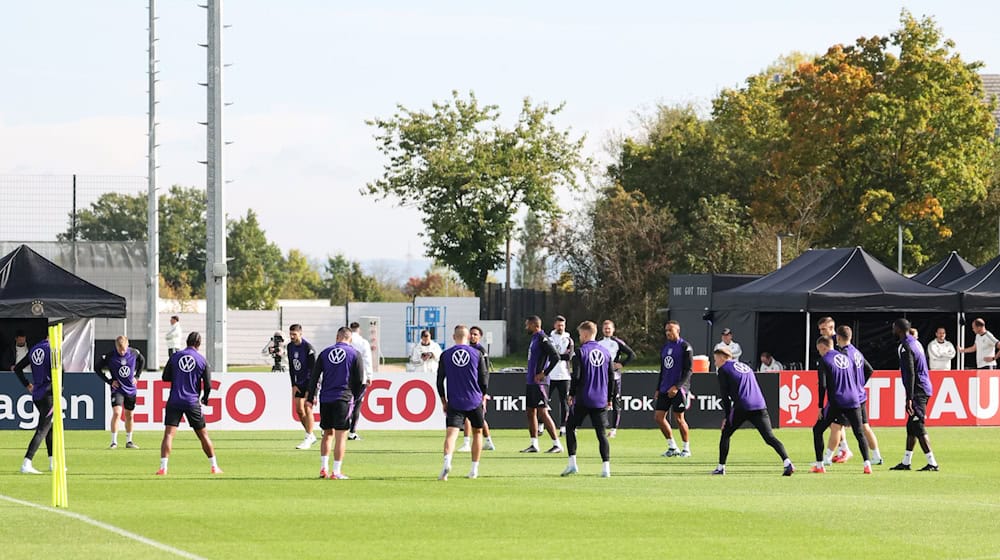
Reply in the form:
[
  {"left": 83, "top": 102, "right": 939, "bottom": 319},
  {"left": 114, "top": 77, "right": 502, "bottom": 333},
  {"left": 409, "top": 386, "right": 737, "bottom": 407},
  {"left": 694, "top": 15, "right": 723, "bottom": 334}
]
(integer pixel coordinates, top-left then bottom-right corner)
[{"left": 226, "top": 210, "right": 283, "bottom": 309}]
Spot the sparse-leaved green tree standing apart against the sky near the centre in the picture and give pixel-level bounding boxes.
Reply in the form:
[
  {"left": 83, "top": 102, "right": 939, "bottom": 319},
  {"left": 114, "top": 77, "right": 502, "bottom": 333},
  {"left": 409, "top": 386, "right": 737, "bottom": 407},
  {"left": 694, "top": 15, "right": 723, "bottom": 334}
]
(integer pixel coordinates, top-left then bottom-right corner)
[{"left": 363, "top": 92, "right": 587, "bottom": 296}]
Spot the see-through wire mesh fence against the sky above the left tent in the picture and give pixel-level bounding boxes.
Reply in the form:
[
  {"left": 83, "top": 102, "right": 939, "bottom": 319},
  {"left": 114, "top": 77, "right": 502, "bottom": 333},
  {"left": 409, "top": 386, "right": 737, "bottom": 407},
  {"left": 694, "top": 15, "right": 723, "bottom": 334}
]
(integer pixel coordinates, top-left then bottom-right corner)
[{"left": 0, "top": 175, "right": 147, "bottom": 241}]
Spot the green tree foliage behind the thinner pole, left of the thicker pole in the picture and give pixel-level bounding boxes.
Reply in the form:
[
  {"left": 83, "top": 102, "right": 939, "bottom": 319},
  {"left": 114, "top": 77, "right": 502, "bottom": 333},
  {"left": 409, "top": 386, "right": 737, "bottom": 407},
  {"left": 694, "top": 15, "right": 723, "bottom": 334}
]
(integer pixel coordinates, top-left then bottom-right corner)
[{"left": 57, "top": 185, "right": 207, "bottom": 296}]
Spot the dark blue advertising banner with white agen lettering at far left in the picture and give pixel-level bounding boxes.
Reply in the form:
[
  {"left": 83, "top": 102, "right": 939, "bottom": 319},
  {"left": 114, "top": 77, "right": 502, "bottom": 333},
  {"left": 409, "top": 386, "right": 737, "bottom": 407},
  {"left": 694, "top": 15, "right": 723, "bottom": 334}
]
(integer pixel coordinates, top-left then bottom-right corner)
[{"left": 0, "top": 372, "right": 108, "bottom": 430}]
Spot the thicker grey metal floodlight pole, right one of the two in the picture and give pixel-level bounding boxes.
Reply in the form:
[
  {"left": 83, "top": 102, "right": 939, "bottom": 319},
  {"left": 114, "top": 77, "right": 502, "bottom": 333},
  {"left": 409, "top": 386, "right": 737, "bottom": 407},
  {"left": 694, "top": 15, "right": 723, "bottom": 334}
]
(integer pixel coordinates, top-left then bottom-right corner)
[{"left": 204, "top": 0, "right": 228, "bottom": 371}]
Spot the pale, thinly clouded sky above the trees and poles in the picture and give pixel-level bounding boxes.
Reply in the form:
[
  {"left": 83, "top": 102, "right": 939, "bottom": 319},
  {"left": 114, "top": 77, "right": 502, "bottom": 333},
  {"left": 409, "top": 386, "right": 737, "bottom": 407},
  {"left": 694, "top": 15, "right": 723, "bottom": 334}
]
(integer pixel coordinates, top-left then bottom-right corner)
[{"left": 0, "top": 0, "right": 1000, "bottom": 266}]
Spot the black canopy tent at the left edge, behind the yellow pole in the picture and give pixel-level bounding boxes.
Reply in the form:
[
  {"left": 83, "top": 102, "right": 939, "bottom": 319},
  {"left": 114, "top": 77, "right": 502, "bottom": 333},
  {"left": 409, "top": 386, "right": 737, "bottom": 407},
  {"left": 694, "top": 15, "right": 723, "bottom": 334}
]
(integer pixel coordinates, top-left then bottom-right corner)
[{"left": 0, "top": 245, "right": 125, "bottom": 354}]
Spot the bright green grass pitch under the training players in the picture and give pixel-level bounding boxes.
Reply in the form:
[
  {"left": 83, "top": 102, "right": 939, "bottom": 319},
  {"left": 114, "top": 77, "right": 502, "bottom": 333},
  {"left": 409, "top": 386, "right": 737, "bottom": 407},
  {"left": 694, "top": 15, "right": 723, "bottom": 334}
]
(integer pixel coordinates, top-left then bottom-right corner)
[{"left": 0, "top": 428, "right": 1000, "bottom": 560}]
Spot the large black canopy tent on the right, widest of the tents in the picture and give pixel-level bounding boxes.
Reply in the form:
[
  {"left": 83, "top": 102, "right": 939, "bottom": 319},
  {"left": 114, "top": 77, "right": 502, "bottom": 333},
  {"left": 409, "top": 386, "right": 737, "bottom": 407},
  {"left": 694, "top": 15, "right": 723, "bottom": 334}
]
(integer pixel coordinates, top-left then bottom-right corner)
[{"left": 713, "top": 247, "right": 959, "bottom": 367}]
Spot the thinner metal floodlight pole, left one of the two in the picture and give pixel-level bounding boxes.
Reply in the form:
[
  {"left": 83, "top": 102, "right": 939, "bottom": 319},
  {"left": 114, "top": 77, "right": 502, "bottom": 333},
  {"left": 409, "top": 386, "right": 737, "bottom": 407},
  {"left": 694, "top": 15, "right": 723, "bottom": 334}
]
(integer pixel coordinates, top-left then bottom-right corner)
[{"left": 146, "top": 0, "right": 160, "bottom": 371}]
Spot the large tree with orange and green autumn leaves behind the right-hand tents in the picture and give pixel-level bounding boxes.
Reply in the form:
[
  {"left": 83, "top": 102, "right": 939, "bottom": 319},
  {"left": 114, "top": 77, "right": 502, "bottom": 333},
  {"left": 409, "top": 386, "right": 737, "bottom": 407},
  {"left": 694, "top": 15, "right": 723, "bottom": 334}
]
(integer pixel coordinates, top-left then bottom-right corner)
[{"left": 756, "top": 10, "right": 996, "bottom": 269}]
